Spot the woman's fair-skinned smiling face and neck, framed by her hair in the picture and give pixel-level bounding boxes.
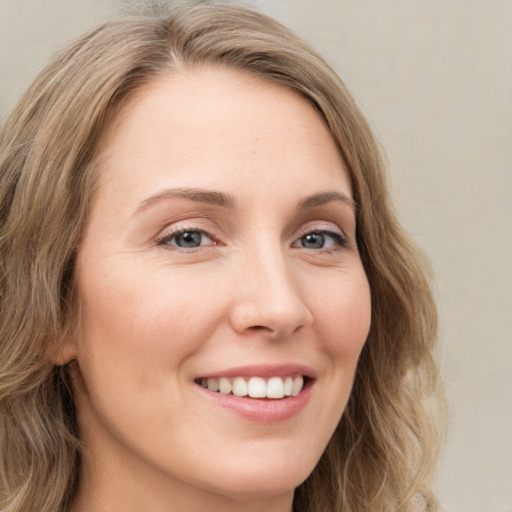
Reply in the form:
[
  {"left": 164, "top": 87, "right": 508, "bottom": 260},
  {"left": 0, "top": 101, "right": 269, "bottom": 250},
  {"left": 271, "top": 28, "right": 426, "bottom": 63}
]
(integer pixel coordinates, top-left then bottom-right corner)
[{"left": 65, "top": 68, "right": 370, "bottom": 512}]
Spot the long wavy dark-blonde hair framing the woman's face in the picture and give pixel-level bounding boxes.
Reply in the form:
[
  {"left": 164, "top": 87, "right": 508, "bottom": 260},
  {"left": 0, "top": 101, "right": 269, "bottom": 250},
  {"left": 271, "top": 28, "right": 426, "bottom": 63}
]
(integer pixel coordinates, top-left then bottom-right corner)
[{"left": 0, "top": 2, "right": 442, "bottom": 512}]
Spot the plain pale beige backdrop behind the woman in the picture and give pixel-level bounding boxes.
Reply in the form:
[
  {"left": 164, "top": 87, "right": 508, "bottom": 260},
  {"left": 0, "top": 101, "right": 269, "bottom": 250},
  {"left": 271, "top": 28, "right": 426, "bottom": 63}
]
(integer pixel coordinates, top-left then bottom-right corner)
[{"left": 0, "top": 0, "right": 512, "bottom": 512}]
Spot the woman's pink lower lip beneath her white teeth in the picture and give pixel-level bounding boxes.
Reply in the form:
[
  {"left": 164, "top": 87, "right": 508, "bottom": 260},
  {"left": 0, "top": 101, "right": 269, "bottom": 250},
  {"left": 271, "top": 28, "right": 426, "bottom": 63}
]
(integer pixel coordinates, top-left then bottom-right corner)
[{"left": 196, "top": 381, "right": 314, "bottom": 423}]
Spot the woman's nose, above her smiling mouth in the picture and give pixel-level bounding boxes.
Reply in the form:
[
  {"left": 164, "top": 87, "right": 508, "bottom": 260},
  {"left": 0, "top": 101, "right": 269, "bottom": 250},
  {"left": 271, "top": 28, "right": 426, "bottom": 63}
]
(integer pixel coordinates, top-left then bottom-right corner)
[{"left": 231, "top": 249, "right": 313, "bottom": 339}]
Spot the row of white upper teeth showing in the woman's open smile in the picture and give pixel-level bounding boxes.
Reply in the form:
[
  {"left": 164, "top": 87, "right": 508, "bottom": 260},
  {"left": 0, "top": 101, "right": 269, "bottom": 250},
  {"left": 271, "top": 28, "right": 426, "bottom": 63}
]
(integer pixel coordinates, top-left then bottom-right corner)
[{"left": 195, "top": 375, "right": 309, "bottom": 400}]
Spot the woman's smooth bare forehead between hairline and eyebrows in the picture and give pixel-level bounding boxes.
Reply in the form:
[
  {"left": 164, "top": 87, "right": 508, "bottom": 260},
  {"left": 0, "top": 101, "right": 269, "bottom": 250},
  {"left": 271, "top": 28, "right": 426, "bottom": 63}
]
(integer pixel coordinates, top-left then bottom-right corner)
[{"left": 93, "top": 68, "right": 350, "bottom": 210}]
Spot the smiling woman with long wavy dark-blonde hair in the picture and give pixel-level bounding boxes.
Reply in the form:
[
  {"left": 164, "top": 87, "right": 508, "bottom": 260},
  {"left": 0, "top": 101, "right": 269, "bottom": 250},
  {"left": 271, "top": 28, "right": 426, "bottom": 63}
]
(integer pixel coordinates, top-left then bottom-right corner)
[{"left": 0, "top": 3, "right": 440, "bottom": 512}]
